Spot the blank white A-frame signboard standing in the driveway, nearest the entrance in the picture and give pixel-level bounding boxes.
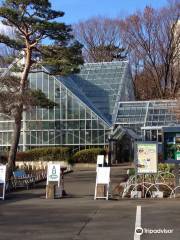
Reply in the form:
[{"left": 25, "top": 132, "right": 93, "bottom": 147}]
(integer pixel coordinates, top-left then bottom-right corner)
[{"left": 94, "top": 167, "right": 110, "bottom": 200}]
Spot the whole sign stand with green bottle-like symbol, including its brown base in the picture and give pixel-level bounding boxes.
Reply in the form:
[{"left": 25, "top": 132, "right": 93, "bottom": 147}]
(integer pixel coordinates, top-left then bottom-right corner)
[{"left": 46, "top": 162, "right": 62, "bottom": 198}]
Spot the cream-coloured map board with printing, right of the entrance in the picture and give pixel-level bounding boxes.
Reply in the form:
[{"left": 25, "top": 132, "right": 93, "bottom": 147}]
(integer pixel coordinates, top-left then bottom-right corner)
[{"left": 136, "top": 142, "right": 158, "bottom": 174}]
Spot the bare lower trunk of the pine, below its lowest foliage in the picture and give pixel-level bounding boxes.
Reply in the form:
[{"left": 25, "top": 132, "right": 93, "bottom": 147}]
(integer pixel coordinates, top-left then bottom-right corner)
[{"left": 7, "top": 112, "right": 22, "bottom": 180}]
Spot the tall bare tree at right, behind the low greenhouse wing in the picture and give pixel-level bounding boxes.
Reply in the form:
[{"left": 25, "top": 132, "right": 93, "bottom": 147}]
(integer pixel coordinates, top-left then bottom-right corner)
[{"left": 119, "top": 2, "right": 180, "bottom": 98}]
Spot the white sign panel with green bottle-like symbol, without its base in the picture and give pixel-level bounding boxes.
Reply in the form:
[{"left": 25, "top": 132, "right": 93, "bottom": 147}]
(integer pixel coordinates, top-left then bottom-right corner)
[{"left": 47, "top": 163, "right": 61, "bottom": 185}]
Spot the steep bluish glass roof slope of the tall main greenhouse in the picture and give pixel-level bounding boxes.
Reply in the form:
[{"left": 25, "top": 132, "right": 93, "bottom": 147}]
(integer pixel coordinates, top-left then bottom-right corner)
[{"left": 59, "top": 61, "right": 134, "bottom": 124}]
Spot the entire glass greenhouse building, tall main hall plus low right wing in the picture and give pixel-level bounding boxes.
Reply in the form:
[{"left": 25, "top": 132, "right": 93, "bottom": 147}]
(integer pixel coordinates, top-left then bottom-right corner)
[{"left": 0, "top": 61, "right": 179, "bottom": 150}]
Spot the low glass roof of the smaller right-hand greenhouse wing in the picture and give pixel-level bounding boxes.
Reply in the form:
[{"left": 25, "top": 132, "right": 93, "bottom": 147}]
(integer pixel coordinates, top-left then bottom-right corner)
[{"left": 115, "top": 100, "right": 180, "bottom": 135}]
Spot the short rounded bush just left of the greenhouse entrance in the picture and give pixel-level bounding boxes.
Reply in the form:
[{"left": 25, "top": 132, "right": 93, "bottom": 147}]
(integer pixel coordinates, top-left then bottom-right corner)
[{"left": 72, "top": 148, "right": 106, "bottom": 163}]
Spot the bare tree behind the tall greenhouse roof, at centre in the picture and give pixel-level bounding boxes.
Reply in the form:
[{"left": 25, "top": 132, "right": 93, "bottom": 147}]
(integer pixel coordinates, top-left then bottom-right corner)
[{"left": 73, "top": 17, "right": 126, "bottom": 62}]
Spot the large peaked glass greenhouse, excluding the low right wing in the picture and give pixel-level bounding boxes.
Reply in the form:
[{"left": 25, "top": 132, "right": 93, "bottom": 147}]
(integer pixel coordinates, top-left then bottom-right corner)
[{"left": 0, "top": 61, "right": 134, "bottom": 150}]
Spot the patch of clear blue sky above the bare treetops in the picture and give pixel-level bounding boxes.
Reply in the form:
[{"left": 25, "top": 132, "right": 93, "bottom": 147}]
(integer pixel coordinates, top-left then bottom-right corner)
[{"left": 51, "top": 0, "right": 167, "bottom": 24}]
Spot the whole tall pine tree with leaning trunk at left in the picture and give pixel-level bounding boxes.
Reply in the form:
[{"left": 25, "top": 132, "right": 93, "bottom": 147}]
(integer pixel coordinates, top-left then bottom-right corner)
[{"left": 0, "top": 0, "right": 83, "bottom": 180}]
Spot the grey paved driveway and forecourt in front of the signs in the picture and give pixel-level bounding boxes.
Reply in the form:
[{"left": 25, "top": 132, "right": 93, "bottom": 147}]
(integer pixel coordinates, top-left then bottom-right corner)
[{"left": 0, "top": 168, "right": 180, "bottom": 240}]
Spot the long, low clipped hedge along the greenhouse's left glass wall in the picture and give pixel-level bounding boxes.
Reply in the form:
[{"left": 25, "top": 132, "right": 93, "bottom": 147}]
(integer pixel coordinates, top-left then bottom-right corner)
[{"left": 16, "top": 147, "right": 70, "bottom": 161}]
